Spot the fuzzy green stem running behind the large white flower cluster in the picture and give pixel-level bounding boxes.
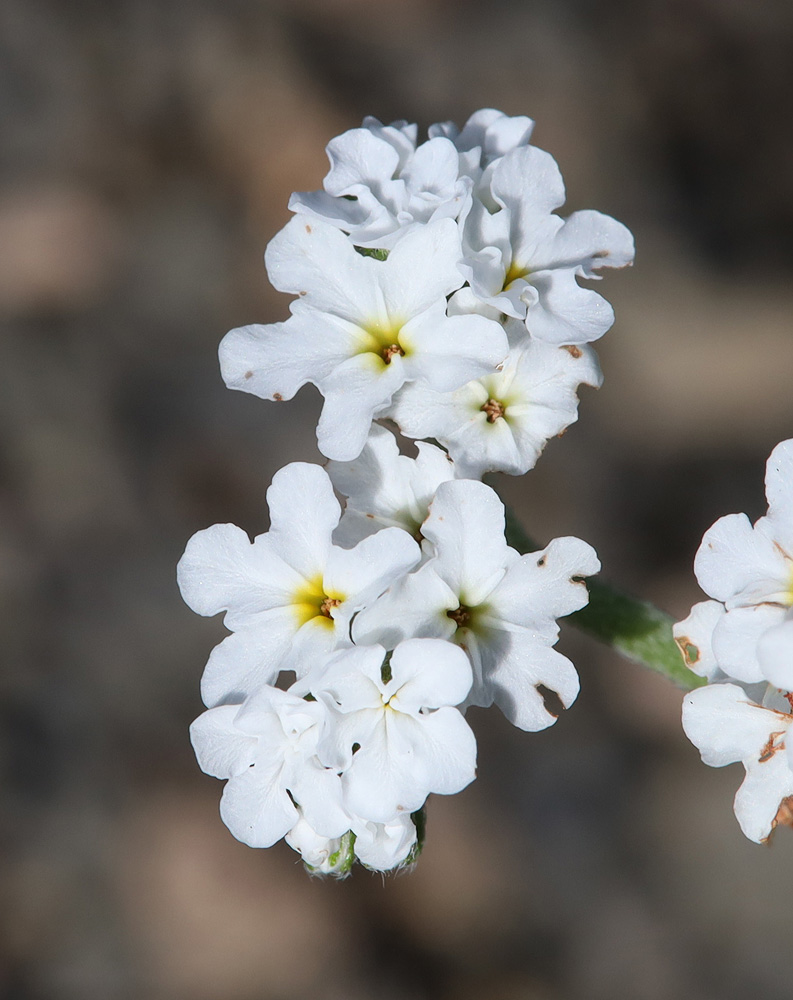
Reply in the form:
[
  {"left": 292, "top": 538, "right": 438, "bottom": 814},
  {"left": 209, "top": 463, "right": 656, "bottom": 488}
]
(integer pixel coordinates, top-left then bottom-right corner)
[{"left": 507, "top": 508, "right": 705, "bottom": 691}]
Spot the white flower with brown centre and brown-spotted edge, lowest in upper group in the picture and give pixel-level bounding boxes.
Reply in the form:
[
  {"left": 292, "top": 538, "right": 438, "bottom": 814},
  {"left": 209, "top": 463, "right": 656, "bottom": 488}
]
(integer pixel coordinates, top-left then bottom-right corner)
[{"left": 389, "top": 321, "right": 602, "bottom": 479}]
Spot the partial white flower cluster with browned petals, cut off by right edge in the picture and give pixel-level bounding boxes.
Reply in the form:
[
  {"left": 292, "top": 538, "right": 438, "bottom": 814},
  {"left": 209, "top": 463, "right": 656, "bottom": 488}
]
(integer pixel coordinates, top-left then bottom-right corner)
[{"left": 674, "top": 440, "right": 793, "bottom": 843}]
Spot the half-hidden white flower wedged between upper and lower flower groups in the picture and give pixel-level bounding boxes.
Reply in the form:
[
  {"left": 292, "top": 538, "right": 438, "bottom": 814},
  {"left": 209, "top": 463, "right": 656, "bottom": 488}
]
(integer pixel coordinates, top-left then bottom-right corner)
[{"left": 327, "top": 424, "right": 454, "bottom": 545}]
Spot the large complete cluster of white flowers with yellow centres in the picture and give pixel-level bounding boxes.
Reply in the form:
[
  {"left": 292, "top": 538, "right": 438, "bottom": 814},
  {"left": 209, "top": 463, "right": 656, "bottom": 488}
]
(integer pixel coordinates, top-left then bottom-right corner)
[{"left": 179, "top": 110, "right": 633, "bottom": 874}]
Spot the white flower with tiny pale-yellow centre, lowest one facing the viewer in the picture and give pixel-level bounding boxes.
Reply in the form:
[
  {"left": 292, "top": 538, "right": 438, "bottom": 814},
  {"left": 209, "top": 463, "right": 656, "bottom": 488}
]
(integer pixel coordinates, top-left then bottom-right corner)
[{"left": 301, "top": 639, "right": 476, "bottom": 824}]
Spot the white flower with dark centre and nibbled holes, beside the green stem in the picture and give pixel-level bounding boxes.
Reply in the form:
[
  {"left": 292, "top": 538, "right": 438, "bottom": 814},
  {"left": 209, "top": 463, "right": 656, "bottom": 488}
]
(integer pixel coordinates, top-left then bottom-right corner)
[{"left": 353, "top": 480, "right": 600, "bottom": 730}]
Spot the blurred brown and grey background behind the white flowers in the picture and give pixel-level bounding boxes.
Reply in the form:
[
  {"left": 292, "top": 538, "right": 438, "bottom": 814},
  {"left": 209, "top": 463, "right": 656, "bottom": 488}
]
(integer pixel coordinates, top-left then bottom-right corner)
[{"left": 0, "top": 0, "right": 793, "bottom": 1000}]
